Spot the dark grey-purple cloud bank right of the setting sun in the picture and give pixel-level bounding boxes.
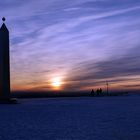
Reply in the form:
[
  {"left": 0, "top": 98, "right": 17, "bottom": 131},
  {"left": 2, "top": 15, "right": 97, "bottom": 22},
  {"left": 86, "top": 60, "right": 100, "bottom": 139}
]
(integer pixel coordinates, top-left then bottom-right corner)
[{"left": 63, "top": 47, "right": 140, "bottom": 89}]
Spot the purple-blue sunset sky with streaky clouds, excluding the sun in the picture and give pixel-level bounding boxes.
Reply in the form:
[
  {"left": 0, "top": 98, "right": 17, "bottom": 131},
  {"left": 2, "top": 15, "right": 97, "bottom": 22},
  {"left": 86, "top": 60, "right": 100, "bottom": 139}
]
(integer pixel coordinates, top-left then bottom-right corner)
[{"left": 0, "top": 0, "right": 140, "bottom": 91}]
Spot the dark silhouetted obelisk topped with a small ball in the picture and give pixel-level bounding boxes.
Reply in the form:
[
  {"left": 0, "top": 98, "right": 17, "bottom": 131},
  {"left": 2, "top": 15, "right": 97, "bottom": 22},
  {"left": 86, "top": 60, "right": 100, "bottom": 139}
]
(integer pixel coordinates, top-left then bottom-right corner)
[{"left": 0, "top": 17, "right": 10, "bottom": 100}]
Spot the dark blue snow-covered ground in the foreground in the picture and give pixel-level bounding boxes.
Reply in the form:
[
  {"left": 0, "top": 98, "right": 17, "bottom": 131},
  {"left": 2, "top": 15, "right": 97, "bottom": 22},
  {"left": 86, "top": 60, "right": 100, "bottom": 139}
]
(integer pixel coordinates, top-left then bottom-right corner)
[{"left": 0, "top": 96, "right": 140, "bottom": 140}]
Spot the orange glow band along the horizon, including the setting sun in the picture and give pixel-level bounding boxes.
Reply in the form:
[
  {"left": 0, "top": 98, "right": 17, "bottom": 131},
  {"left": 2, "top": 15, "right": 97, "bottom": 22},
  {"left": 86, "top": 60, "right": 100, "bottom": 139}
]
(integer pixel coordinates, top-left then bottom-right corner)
[{"left": 11, "top": 74, "right": 140, "bottom": 91}]
